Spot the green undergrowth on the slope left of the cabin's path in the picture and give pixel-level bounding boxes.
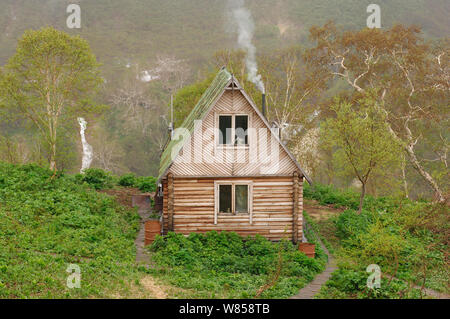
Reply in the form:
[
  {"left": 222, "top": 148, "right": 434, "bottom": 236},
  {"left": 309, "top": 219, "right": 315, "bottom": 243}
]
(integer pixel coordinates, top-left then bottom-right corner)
[{"left": 0, "top": 163, "right": 139, "bottom": 298}]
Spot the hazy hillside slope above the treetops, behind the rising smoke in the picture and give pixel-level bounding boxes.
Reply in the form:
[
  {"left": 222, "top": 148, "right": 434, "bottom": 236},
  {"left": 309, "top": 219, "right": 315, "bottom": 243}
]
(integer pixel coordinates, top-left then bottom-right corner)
[{"left": 0, "top": 0, "right": 450, "bottom": 70}]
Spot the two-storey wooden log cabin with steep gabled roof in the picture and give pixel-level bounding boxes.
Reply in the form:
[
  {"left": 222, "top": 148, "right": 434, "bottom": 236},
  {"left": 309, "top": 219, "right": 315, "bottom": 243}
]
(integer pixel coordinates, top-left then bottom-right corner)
[{"left": 158, "top": 68, "right": 309, "bottom": 243}]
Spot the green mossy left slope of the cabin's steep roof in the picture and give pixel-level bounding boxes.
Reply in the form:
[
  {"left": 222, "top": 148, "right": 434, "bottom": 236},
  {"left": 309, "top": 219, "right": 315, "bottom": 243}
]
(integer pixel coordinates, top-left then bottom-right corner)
[{"left": 158, "top": 68, "right": 231, "bottom": 180}]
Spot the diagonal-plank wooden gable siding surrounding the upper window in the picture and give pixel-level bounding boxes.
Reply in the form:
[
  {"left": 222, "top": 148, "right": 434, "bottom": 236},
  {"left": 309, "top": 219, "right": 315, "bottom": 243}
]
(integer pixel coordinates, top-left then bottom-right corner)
[{"left": 169, "top": 90, "right": 297, "bottom": 176}]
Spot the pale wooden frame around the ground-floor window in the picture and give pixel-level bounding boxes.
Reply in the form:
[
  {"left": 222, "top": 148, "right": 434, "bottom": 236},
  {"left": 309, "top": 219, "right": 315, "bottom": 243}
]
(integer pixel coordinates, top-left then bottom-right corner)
[{"left": 214, "top": 180, "right": 253, "bottom": 225}]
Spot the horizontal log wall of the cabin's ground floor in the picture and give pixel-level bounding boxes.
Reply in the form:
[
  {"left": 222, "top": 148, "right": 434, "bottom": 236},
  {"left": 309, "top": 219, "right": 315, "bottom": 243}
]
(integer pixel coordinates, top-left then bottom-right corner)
[{"left": 163, "top": 176, "right": 303, "bottom": 240}]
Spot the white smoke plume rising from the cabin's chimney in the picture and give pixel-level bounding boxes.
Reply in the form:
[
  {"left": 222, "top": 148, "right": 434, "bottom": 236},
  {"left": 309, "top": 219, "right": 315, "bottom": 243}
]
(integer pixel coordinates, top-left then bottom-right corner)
[{"left": 228, "top": 0, "right": 265, "bottom": 93}]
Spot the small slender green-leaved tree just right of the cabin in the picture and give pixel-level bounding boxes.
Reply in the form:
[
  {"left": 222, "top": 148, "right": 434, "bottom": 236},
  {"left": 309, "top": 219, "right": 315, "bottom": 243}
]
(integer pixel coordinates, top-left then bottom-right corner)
[{"left": 321, "top": 95, "right": 401, "bottom": 213}]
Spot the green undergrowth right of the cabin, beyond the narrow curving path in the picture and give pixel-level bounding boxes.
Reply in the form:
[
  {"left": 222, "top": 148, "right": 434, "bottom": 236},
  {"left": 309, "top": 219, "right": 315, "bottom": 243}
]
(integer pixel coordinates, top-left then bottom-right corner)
[{"left": 305, "top": 185, "right": 450, "bottom": 298}]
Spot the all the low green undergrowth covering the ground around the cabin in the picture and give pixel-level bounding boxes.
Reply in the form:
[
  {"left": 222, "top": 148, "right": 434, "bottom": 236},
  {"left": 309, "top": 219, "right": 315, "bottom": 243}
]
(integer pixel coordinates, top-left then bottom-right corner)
[{"left": 0, "top": 163, "right": 450, "bottom": 298}]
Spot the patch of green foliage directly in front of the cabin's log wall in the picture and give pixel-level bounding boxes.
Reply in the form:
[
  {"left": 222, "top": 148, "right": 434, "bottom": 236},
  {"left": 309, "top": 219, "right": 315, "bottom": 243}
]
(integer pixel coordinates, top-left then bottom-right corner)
[{"left": 146, "top": 231, "right": 325, "bottom": 298}]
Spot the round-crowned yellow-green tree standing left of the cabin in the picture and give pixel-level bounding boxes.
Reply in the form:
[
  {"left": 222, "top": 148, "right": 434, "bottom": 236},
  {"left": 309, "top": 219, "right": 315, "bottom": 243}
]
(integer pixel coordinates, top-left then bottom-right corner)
[{"left": 0, "top": 27, "right": 102, "bottom": 171}]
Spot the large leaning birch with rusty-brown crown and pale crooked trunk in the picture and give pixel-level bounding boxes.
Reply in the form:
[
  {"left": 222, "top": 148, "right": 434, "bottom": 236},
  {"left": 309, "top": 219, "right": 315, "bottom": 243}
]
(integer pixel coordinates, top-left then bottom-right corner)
[{"left": 307, "top": 23, "right": 450, "bottom": 202}]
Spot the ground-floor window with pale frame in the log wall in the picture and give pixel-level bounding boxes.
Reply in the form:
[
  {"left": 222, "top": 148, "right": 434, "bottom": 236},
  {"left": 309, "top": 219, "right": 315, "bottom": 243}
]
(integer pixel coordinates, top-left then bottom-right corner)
[{"left": 214, "top": 181, "right": 252, "bottom": 224}]
